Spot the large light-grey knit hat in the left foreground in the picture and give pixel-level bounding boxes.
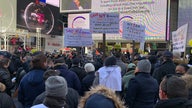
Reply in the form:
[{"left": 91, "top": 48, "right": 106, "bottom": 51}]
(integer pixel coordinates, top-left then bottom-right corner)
[{"left": 45, "top": 76, "right": 68, "bottom": 97}]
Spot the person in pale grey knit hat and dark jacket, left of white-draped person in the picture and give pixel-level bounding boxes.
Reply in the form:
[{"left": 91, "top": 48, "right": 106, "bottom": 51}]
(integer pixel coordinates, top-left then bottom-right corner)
[{"left": 82, "top": 63, "right": 95, "bottom": 93}]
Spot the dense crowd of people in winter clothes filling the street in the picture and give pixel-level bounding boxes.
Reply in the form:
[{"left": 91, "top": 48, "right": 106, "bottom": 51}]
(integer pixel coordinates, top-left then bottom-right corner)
[{"left": 0, "top": 50, "right": 192, "bottom": 108}]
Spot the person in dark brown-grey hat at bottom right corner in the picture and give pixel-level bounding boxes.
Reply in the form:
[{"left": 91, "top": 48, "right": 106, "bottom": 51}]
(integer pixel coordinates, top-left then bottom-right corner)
[{"left": 154, "top": 75, "right": 192, "bottom": 108}]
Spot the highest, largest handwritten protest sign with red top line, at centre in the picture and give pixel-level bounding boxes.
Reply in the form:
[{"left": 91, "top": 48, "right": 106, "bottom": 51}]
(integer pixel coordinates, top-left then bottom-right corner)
[{"left": 90, "top": 13, "right": 119, "bottom": 33}]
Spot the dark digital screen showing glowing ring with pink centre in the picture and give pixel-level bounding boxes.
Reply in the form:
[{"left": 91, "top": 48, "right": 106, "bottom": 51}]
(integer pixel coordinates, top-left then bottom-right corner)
[{"left": 17, "top": 0, "right": 63, "bottom": 35}]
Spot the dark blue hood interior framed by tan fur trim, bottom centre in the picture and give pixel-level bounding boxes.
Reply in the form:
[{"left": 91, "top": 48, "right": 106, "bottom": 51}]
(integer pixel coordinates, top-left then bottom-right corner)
[{"left": 84, "top": 93, "right": 115, "bottom": 108}]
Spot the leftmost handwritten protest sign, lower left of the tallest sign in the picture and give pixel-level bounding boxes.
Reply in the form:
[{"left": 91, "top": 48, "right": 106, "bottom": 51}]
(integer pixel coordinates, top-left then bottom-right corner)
[{"left": 64, "top": 28, "right": 93, "bottom": 47}]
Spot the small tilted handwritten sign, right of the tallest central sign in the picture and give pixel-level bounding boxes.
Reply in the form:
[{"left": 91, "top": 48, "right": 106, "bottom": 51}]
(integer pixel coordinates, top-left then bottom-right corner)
[{"left": 122, "top": 22, "right": 145, "bottom": 42}]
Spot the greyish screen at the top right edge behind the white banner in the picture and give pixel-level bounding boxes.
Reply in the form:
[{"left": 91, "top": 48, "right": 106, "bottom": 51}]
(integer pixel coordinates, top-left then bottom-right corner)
[{"left": 178, "top": 0, "right": 192, "bottom": 43}]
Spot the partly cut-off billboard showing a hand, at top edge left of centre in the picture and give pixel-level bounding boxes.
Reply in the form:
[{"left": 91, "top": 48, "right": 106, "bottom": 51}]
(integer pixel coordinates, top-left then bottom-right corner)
[{"left": 60, "top": 0, "right": 92, "bottom": 13}]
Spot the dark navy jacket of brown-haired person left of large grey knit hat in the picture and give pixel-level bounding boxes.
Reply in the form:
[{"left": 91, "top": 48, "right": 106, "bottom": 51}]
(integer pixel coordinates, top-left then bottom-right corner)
[{"left": 18, "top": 69, "right": 45, "bottom": 108}]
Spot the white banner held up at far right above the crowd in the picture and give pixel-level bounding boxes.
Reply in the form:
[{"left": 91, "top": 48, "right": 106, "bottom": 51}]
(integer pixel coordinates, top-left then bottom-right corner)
[{"left": 172, "top": 24, "right": 188, "bottom": 52}]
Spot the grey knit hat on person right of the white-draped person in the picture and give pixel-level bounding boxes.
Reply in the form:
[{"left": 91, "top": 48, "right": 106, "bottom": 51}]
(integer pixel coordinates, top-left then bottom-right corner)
[{"left": 137, "top": 59, "right": 151, "bottom": 73}]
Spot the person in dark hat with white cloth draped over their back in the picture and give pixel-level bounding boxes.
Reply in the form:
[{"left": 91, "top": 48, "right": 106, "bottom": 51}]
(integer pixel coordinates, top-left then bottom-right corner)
[{"left": 96, "top": 56, "right": 122, "bottom": 92}]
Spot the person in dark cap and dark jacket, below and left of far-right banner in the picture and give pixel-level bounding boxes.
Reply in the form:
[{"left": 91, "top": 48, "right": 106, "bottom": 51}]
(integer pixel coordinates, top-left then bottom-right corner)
[{"left": 152, "top": 51, "right": 176, "bottom": 84}]
